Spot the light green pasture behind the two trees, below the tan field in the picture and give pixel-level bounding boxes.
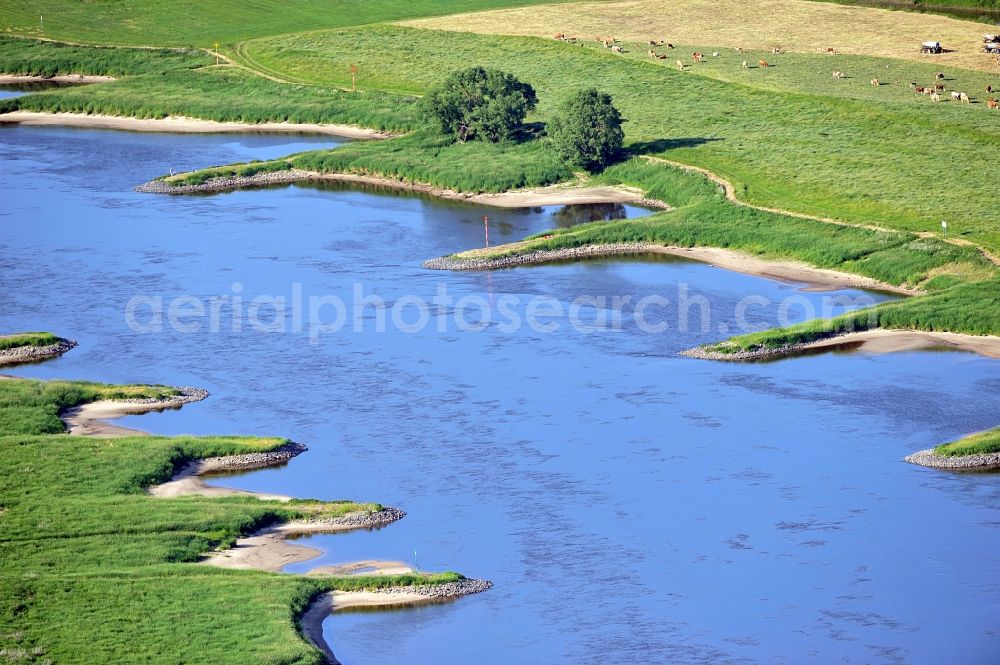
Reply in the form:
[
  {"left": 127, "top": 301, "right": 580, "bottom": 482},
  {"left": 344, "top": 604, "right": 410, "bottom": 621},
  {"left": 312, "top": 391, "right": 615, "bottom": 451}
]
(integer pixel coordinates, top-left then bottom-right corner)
[{"left": 240, "top": 26, "right": 1000, "bottom": 248}]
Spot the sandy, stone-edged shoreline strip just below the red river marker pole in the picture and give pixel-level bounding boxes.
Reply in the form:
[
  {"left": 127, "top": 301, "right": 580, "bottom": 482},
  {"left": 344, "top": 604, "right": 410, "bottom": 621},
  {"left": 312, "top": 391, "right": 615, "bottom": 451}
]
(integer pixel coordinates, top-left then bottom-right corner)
[{"left": 423, "top": 243, "right": 920, "bottom": 295}]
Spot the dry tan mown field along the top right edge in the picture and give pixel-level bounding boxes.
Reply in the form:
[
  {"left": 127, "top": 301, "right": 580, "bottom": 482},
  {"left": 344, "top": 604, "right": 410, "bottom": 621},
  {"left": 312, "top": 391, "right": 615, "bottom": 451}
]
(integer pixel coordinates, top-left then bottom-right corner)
[{"left": 406, "top": 0, "right": 995, "bottom": 71}]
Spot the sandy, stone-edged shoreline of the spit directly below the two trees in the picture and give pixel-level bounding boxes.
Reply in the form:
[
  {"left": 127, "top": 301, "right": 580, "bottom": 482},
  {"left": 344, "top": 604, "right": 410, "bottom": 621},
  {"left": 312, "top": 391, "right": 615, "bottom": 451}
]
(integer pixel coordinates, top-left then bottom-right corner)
[{"left": 131, "top": 167, "right": 670, "bottom": 210}]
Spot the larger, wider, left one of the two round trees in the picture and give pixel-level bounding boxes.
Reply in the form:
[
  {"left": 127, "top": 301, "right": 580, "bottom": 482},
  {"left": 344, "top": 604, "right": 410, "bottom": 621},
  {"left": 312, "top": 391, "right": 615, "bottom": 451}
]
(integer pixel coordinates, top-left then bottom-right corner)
[{"left": 425, "top": 67, "right": 538, "bottom": 143}]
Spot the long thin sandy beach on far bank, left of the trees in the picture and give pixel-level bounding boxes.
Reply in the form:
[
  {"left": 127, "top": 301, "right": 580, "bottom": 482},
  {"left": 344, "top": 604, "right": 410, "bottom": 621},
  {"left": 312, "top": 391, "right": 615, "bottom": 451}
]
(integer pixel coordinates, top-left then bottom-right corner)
[{"left": 0, "top": 111, "right": 394, "bottom": 139}]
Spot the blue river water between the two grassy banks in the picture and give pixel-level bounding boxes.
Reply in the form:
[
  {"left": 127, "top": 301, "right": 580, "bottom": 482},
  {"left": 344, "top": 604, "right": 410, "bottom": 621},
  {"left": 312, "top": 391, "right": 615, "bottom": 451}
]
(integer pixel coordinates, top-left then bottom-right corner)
[{"left": 0, "top": 127, "right": 1000, "bottom": 665}]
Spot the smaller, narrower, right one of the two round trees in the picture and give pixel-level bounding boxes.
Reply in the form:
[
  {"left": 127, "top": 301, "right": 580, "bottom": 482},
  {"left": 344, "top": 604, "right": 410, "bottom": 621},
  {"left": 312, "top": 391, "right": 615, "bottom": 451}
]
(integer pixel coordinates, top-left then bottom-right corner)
[{"left": 548, "top": 88, "right": 625, "bottom": 171}]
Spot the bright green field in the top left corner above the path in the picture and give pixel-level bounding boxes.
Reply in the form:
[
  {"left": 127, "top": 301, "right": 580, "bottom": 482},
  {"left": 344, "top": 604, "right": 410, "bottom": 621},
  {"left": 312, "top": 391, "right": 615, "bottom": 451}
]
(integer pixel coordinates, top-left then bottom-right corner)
[{"left": 0, "top": 0, "right": 576, "bottom": 47}]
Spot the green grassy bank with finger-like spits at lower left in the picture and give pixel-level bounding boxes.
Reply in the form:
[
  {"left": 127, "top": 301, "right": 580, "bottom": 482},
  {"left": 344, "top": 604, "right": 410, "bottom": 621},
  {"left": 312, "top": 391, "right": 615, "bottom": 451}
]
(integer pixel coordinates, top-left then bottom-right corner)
[{"left": 0, "top": 379, "right": 460, "bottom": 665}]
